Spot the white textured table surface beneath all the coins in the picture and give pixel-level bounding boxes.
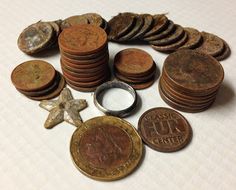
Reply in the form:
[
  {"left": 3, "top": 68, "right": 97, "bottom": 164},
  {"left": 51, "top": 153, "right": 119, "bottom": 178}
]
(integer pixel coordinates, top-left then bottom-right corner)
[{"left": 0, "top": 0, "right": 236, "bottom": 190}]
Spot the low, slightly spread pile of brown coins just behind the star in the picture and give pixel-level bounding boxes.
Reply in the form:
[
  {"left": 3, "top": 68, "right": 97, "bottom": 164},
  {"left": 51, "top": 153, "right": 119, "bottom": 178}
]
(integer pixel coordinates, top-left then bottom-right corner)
[{"left": 11, "top": 60, "right": 65, "bottom": 101}]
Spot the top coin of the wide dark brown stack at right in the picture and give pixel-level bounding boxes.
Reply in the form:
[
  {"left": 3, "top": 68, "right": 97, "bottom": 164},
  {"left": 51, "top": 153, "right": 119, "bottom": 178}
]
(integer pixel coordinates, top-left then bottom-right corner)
[{"left": 163, "top": 50, "right": 224, "bottom": 93}]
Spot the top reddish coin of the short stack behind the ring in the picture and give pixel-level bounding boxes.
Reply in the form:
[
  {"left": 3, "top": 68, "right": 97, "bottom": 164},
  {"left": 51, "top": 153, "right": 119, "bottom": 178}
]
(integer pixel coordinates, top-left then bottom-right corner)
[{"left": 114, "top": 48, "right": 154, "bottom": 76}]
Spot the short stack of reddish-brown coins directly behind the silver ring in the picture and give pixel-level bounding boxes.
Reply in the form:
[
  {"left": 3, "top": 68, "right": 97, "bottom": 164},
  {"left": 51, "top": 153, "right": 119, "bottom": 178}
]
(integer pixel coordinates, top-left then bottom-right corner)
[{"left": 114, "top": 48, "right": 156, "bottom": 90}]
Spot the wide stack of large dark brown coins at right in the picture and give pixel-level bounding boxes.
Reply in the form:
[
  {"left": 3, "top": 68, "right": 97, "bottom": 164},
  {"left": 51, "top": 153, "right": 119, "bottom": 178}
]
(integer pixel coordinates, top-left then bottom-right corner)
[{"left": 159, "top": 50, "right": 224, "bottom": 112}]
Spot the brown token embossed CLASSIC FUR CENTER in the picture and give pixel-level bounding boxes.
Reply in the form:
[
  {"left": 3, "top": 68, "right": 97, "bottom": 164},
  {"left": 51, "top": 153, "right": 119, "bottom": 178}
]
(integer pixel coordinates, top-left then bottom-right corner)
[{"left": 138, "top": 107, "right": 192, "bottom": 152}]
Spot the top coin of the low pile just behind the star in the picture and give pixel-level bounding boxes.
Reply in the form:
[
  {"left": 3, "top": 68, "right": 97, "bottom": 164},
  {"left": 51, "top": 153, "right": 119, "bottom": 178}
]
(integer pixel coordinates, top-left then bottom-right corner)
[{"left": 11, "top": 60, "right": 56, "bottom": 91}]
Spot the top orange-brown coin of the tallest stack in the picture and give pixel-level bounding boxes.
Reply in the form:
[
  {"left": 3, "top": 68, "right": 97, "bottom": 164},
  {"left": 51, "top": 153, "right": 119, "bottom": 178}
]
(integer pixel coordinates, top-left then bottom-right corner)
[{"left": 59, "top": 24, "right": 107, "bottom": 55}]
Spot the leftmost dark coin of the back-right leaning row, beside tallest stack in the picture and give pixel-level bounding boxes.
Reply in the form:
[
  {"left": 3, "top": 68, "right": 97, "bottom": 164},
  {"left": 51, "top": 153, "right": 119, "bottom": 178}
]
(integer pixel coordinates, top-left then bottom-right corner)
[{"left": 108, "top": 13, "right": 134, "bottom": 40}]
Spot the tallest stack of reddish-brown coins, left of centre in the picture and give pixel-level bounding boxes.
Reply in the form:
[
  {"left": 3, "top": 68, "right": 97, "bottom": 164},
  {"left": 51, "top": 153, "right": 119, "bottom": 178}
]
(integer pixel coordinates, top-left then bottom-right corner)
[{"left": 58, "top": 24, "right": 110, "bottom": 92}]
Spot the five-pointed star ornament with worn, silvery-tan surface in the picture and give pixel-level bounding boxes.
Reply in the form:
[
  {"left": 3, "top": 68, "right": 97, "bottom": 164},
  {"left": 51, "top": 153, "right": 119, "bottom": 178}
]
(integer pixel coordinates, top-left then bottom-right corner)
[{"left": 39, "top": 88, "right": 87, "bottom": 129}]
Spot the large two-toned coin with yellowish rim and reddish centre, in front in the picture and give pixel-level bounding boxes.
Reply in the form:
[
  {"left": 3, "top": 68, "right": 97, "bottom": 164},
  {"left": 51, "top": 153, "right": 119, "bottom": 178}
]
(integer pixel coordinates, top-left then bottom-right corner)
[{"left": 70, "top": 116, "right": 143, "bottom": 181}]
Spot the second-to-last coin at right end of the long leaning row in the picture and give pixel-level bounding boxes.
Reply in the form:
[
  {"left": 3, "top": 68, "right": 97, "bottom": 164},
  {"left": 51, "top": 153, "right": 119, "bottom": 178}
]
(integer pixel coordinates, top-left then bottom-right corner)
[{"left": 196, "top": 32, "right": 224, "bottom": 56}]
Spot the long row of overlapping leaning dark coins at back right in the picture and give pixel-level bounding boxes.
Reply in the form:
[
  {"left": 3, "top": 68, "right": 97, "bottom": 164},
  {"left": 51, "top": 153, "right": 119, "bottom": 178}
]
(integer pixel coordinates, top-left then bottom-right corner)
[{"left": 108, "top": 13, "right": 230, "bottom": 60}]
